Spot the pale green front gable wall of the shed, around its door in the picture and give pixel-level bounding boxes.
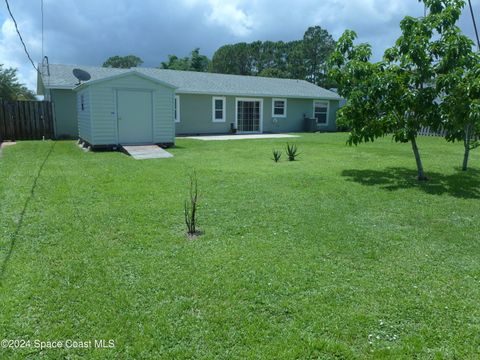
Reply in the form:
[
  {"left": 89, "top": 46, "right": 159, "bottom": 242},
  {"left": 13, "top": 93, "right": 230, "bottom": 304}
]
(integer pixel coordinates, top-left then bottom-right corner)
[{"left": 83, "top": 74, "right": 175, "bottom": 145}]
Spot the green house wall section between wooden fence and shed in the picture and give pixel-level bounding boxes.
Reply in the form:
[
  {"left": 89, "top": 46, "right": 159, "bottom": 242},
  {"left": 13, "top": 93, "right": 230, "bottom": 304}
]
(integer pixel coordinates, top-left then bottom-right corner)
[{"left": 50, "top": 89, "right": 78, "bottom": 139}]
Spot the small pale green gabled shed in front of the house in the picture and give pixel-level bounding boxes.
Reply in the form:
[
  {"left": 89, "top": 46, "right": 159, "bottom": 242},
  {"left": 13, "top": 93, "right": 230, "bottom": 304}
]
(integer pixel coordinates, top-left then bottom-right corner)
[{"left": 75, "top": 70, "right": 175, "bottom": 148}]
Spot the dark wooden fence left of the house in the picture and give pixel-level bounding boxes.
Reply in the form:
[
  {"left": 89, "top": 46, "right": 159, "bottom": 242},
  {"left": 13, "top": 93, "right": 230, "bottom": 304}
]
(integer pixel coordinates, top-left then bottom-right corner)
[{"left": 0, "top": 100, "right": 54, "bottom": 143}]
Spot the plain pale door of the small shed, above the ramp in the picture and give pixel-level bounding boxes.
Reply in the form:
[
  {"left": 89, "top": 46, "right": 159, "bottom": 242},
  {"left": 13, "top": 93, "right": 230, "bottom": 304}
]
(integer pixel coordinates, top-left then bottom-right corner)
[{"left": 117, "top": 90, "right": 153, "bottom": 145}]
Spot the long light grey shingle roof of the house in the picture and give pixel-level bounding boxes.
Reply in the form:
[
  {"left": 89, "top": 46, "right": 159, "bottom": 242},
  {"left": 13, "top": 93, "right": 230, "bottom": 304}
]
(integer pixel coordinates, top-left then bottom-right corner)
[{"left": 42, "top": 64, "right": 340, "bottom": 99}]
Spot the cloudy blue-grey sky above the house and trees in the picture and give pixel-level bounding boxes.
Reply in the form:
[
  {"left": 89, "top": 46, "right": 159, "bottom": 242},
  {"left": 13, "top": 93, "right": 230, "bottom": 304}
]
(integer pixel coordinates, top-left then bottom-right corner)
[{"left": 0, "top": 0, "right": 480, "bottom": 90}]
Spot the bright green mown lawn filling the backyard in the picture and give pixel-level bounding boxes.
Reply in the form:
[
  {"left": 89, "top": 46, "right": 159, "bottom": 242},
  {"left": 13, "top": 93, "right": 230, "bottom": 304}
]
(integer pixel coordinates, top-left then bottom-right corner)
[{"left": 0, "top": 134, "right": 480, "bottom": 359}]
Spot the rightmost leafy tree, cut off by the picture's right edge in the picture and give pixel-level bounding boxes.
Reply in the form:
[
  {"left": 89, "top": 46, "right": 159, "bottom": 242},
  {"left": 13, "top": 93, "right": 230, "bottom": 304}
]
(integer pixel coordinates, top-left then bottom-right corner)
[{"left": 430, "top": 4, "right": 480, "bottom": 171}]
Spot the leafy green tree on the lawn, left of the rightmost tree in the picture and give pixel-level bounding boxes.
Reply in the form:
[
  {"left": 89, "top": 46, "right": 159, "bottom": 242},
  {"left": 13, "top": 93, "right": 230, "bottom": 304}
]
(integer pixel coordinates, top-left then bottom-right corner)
[{"left": 332, "top": 17, "right": 437, "bottom": 180}]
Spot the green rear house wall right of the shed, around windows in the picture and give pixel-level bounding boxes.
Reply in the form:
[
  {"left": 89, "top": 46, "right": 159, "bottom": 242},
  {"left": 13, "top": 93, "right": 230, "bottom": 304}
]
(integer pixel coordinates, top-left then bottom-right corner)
[{"left": 175, "top": 94, "right": 338, "bottom": 135}]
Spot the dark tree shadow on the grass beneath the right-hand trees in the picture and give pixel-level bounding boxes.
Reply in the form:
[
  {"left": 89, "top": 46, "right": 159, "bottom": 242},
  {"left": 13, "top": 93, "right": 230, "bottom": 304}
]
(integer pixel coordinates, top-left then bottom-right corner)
[{"left": 342, "top": 167, "right": 480, "bottom": 199}]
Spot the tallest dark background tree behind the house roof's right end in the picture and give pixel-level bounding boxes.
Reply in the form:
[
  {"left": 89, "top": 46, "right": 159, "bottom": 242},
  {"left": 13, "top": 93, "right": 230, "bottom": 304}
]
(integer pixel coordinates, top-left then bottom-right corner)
[{"left": 303, "top": 26, "right": 335, "bottom": 86}]
